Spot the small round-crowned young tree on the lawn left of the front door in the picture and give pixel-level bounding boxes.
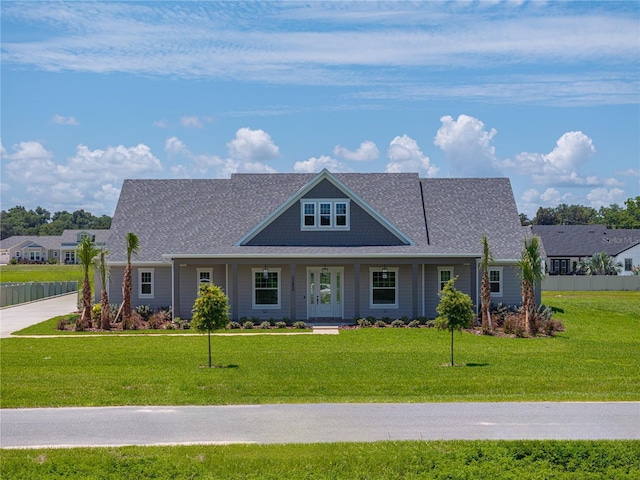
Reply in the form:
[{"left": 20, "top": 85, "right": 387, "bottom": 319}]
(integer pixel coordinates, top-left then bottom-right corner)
[{"left": 191, "top": 283, "right": 229, "bottom": 368}]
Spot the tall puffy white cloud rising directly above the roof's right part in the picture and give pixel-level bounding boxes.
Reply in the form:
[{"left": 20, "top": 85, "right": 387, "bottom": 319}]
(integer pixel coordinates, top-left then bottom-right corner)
[{"left": 433, "top": 114, "right": 500, "bottom": 177}]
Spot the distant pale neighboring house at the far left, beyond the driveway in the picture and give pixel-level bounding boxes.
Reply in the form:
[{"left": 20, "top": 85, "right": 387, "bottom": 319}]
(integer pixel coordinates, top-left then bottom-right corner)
[{"left": 0, "top": 230, "right": 109, "bottom": 265}]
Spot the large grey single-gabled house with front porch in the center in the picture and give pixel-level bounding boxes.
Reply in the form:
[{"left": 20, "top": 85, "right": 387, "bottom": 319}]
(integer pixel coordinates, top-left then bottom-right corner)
[{"left": 102, "top": 170, "right": 530, "bottom": 323}]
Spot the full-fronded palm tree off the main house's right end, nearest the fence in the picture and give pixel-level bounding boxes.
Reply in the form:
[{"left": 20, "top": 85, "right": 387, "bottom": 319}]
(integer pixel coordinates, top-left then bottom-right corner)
[{"left": 518, "top": 236, "right": 544, "bottom": 335}]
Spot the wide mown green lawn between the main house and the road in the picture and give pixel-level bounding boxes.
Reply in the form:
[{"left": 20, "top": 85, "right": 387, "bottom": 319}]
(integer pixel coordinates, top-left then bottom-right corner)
[{"left": 0, "top": 292, "right": 640, "bottom": 408}]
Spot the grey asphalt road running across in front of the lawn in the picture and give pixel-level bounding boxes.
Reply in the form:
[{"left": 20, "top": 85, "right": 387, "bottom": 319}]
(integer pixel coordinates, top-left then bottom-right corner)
[{"left": 0, "top": 402, "right": 640, "bottom": 448}]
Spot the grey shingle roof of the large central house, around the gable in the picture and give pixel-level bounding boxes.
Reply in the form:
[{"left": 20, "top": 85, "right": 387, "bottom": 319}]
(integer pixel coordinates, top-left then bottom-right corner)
[{"left": 107, "top": 173, "right": 523, "bottom": 262}]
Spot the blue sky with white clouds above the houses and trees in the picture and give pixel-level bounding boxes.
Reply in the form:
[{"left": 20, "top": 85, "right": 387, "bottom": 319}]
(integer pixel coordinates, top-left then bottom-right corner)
[{"left": 0, "top": 0, "right": 640, "bottom": 217}]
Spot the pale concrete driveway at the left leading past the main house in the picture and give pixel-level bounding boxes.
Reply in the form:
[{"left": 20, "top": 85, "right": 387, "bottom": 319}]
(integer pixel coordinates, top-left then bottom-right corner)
[{"left": 0, "top": 292, "right": 78, "bottom": 338}]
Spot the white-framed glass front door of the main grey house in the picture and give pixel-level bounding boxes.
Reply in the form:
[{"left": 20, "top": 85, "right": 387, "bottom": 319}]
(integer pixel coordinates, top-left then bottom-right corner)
[{"left": 307, "top": 267, "right": 344, "bottom": 320}]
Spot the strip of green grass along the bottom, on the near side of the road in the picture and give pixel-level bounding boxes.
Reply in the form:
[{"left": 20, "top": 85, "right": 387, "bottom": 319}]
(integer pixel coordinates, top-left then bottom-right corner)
[{"left": 0, "top": 441, "right": 640, "bottom": 480}]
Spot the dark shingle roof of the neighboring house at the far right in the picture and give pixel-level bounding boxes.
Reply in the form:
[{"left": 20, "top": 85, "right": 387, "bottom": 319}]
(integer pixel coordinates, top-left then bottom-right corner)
[{"left": 532, "top": 225, "right": 640, "bottom": 257}]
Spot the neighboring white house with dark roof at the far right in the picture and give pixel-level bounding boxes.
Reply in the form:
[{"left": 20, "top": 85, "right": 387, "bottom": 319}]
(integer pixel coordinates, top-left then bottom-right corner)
[{"left": 532, "top": 225, "right": 640, "bottom": 275}]
